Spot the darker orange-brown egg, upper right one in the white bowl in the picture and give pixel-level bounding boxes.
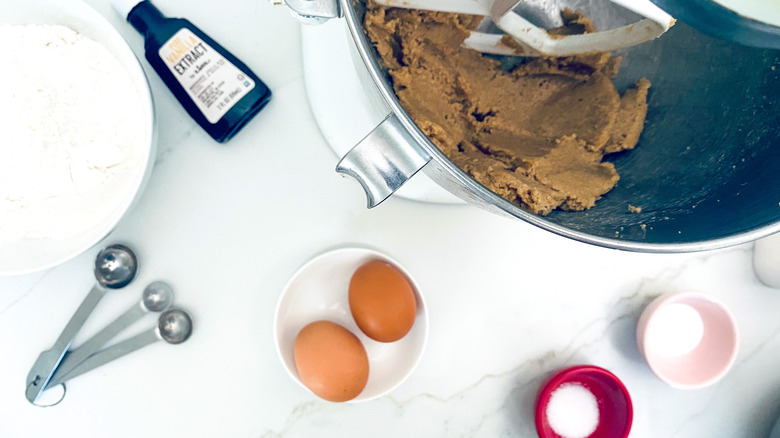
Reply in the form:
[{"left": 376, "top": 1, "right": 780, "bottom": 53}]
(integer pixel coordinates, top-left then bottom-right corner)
[{"left": 349, "top": 260, "right": 417, "bottom": 342}]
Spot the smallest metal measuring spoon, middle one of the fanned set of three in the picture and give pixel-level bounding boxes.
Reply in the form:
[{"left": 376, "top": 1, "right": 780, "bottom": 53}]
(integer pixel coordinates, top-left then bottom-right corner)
[{"left": 49, "top": 281, "right": 173, "bottom": 386}]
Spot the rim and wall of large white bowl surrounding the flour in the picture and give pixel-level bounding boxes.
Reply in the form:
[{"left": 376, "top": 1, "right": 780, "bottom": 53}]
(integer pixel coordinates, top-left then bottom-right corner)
[{"left": 0, "top": 0, "right": 156, "bottom": 275}]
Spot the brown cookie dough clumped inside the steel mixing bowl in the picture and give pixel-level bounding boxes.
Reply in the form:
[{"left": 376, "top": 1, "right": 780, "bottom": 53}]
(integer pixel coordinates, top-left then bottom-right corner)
[{"left": 364, "top": 0, "right": 650, "bottom": 215}]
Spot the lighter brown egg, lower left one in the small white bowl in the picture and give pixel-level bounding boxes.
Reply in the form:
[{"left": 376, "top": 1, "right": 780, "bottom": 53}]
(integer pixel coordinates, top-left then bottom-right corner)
[{"left": 293, "top": 321, "right": 368, "bottom": 402}]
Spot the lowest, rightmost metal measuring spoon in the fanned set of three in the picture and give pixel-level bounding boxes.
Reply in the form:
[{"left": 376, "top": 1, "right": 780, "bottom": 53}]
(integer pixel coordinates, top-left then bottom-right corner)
[{"left": 57, "top": 309, "right": 192, "bottom": 383}]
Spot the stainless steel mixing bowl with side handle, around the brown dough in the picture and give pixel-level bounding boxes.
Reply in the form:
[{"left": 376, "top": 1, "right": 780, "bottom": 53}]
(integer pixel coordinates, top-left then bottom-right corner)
[{"left": 287, "top": 0, "right": 780, "bottom": 252}]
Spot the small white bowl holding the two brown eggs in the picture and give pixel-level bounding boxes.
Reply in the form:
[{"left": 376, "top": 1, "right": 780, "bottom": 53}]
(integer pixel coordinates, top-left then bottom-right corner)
[{"left": 274, "top": 247, "right": 428, "bottom": 402}]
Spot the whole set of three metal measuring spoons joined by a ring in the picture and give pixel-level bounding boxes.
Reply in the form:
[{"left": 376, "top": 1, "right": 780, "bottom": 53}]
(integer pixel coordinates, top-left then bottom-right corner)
[{"left": 25, "top": 244, "right": 192, "bottom": 406}]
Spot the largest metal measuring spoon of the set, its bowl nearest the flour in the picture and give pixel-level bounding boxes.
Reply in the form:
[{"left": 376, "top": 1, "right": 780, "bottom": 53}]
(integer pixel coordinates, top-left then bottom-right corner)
[{"left": 24, "top": 245, "right": 138, "bottom": 404}]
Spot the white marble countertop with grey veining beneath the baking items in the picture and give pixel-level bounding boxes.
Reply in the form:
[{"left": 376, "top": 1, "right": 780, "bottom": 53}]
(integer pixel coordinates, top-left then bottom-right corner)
[{"left": 0, "top": 0, "right": 780, "bottom": 438}]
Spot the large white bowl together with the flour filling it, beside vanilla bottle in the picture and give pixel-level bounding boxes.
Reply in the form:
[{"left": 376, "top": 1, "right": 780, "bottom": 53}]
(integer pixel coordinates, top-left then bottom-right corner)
[{"left": 0, "top": 0, "right": 156, "bottom": 275}]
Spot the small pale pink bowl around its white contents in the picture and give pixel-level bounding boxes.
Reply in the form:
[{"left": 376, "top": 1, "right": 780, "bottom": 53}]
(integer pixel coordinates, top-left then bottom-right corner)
[{"left": 636, "top": 292, "right": 739, "bottom": 389}]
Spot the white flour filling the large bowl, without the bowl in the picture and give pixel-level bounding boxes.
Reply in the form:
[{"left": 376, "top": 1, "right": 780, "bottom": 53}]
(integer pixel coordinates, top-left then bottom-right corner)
[{"left": 0, "top": 25, "right": 147, "bottom": 240}]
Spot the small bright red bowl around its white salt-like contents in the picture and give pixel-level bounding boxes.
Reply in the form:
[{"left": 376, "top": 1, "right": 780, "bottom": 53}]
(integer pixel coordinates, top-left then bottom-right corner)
[{"left": 536, "top": 365, "right": 634, "bottom": 438}]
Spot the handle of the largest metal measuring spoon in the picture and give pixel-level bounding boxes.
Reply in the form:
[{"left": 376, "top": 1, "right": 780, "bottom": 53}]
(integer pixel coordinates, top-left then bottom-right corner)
[{"left": 24, "top": 284, "right": 106, "bottom": 403}]
